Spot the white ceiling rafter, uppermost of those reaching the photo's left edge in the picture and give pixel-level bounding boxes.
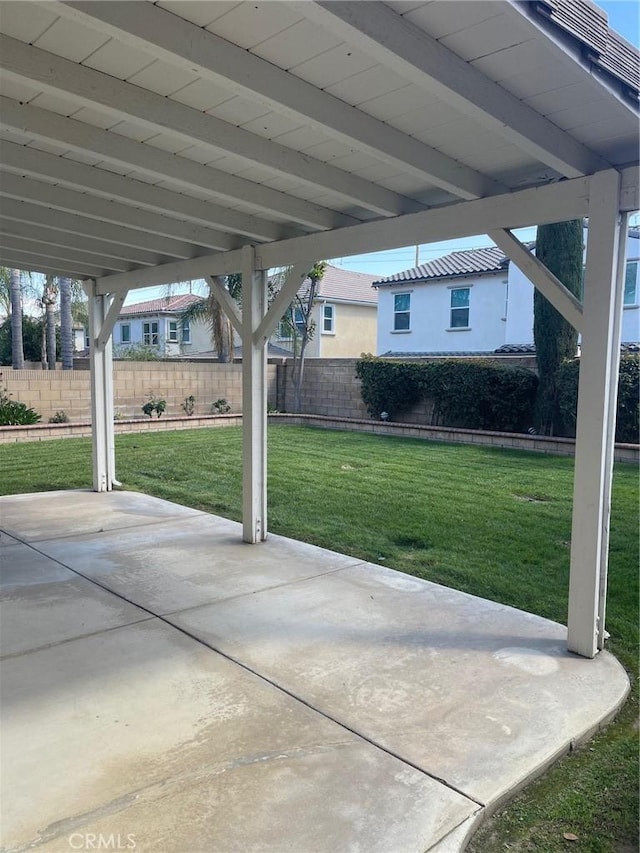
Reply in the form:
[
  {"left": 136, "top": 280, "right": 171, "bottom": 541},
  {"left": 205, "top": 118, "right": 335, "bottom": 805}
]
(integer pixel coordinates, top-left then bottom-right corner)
[{"left": 0, "top": 35, "right": 422, "bottom": 215}]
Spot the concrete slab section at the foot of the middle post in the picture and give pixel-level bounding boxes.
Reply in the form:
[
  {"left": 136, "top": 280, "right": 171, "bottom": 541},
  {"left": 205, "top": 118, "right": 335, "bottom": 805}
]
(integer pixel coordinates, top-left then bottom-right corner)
[{"left": 37, "top": 515, "right": 362, "bottom": 614}]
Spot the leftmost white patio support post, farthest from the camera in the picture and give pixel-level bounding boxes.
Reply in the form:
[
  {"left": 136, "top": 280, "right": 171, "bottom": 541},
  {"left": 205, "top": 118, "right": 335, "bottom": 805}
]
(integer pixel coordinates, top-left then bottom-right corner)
[{"left": 84, "top": 281, "right": 127, "bottom": 492}]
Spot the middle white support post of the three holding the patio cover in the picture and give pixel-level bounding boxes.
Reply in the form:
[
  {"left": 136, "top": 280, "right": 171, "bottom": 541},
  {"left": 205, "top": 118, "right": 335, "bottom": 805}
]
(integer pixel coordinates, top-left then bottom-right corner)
[{"left": 242, "top": 246, "right": 267, "bottom": 543}]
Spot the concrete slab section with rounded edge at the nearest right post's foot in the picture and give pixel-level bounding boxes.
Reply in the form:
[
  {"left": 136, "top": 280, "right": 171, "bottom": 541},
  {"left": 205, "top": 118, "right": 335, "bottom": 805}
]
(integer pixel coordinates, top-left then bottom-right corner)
[{"left": 167, "top": 564, "right": 628, "bottom": 804}]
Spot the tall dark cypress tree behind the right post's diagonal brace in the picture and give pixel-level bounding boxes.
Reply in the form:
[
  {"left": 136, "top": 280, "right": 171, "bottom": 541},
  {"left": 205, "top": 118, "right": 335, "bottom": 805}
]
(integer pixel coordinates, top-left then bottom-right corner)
[{"left": 533, "top": 219, "right": 583, "bottom": 435}]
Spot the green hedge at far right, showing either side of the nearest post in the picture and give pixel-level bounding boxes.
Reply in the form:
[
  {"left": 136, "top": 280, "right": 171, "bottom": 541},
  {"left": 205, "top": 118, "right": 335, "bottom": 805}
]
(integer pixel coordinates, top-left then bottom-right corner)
[{"left": 556, "top": 355, "right": 640, "bottom": 444}]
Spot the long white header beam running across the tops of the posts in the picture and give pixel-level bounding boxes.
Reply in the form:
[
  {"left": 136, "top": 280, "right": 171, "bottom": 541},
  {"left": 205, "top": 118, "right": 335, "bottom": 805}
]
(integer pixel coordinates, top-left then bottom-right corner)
[{"left": 97, "top": 173, "right": 590, "bottom": 293}]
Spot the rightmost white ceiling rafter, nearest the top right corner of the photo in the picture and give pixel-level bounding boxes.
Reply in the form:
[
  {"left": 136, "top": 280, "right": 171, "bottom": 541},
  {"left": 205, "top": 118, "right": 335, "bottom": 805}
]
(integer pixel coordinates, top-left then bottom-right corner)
[{"left": 304, "top": 0, "right": 609, "bottom": 178}]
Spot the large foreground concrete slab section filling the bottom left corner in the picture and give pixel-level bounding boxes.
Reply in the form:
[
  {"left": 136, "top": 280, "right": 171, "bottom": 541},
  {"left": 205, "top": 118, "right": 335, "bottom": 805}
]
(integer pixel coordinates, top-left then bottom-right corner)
[{"left": 2, "top": 619, "right": 478, "bottom": 853}]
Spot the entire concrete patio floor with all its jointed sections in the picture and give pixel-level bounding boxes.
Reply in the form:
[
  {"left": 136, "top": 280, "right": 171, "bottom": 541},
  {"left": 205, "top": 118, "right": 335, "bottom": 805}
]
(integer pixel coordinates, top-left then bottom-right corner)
[{"left": 0, "top": 492, "right": 628, "bottom": 853}]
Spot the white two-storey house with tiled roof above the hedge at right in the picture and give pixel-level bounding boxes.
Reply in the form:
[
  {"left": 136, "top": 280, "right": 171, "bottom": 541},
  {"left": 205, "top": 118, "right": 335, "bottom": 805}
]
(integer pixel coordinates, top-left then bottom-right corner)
[{"left": 374, "top": 228, "right": 640, "bottom": 356}]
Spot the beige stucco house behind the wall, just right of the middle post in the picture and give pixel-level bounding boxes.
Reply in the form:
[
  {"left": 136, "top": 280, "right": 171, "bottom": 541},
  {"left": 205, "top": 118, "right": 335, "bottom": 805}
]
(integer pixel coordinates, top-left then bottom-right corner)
[{"left": 271, "top": 265, "right": 378, "bottom": 358}]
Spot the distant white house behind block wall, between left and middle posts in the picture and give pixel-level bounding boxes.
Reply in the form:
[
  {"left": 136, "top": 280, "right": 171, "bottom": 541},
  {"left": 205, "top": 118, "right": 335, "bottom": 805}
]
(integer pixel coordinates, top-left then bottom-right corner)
[{"left": 113, "top": 294, "right": 211, "bottom": 358}]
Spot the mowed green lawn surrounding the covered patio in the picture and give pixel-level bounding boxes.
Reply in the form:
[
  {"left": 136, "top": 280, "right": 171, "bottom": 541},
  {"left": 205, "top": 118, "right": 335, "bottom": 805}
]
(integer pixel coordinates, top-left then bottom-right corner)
[{"left": 0, "top": 425, "right": 639, "bottom": 853}]
